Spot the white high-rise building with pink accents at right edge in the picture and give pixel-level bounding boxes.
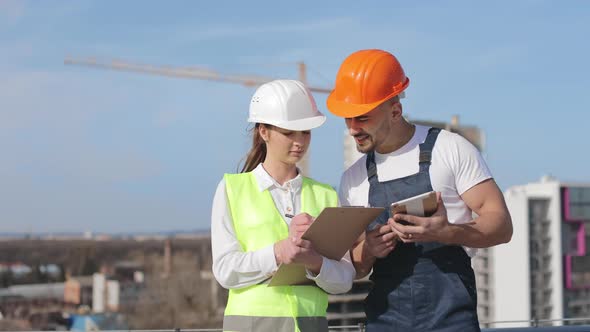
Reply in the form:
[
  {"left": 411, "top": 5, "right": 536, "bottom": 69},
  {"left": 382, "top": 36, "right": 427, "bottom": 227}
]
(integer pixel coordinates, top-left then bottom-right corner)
[{"left": 489, "top": 177, "right": 590, "bottom": 327}]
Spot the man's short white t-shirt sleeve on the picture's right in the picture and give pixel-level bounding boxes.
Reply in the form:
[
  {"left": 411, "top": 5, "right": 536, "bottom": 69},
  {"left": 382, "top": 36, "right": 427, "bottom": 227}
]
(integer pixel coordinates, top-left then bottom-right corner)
[{"left": 453, "top": 134, "right": 492, "bottom": 195}]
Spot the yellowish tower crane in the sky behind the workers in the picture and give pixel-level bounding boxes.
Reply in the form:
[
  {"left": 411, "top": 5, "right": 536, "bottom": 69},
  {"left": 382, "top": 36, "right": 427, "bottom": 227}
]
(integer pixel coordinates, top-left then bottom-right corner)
[{"left": 64, "top": 57, "right": 332, "bottom": 175}]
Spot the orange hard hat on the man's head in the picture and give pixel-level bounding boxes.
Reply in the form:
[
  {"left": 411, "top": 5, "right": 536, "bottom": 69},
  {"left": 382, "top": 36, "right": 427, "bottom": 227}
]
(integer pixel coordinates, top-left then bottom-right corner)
[{"left": 327, "top": 50, "right": 410, "bottom": 118}]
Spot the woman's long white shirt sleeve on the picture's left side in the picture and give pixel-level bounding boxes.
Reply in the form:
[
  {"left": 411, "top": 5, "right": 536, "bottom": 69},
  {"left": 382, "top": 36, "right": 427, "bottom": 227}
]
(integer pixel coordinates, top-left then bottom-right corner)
[{"left": 211, "top": 180, "right": 277, "bottom": 289}]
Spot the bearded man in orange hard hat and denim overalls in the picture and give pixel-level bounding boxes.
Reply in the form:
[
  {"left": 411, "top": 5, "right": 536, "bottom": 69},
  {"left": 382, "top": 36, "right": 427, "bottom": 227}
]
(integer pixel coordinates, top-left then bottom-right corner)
[{"left": 327, "top": 50, "right": 512, "bottom": 331}]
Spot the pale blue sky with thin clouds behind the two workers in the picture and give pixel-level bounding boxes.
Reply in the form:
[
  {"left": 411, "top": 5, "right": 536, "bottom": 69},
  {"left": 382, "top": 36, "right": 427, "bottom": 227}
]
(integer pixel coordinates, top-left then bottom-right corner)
[{"left": 0, "top": 0, "right": 590, "bottom": 233}]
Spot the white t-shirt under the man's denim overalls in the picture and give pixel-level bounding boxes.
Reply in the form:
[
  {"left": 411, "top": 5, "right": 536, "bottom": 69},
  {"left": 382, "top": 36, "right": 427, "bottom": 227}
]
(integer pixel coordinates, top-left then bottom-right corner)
[{"left": 339, "top": 125, "right": 492, "bottom": 257}]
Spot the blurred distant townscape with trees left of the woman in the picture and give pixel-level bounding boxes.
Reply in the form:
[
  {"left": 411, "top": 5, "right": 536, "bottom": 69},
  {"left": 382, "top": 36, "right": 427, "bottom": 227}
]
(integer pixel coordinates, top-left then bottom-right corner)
[{"left": 0, "top": 233, "right": 222, "bottom": 330}]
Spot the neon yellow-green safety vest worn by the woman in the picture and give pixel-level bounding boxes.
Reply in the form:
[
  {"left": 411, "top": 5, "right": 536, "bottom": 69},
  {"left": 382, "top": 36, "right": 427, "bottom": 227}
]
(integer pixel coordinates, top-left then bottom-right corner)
[{"left": 224, "top": 172, "right": 338, "bottom": 331}]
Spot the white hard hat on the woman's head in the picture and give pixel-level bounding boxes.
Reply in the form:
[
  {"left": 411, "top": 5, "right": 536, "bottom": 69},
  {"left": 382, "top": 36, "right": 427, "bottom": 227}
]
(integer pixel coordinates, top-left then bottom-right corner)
[{"left": 248, "top": 80, "right": 326, "bottom": 131}]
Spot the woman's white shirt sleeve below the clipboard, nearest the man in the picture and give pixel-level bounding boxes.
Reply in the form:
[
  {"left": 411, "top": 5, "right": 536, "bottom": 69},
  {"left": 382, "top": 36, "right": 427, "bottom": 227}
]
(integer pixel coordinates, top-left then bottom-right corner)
[{"left": 307, "top": 251, "right": 356, "bottom": 294}]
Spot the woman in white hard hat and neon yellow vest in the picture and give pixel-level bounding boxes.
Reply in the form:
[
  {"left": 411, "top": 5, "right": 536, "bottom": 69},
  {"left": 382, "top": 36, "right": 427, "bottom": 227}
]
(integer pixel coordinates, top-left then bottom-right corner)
[{"left": 211, "top": 80, "right": 355, "bottom": 331}]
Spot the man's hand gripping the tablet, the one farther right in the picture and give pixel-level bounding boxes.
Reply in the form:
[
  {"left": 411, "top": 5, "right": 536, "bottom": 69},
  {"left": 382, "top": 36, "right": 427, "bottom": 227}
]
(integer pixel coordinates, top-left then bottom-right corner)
[{"left": 387, "top": 192, "right": 450, "bottom": 243}]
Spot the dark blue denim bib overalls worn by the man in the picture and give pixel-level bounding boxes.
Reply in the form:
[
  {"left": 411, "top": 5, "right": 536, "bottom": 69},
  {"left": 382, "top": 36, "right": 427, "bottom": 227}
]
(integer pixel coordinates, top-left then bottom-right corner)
[{"left": 365, "top": 128, "right": 480, "bottom": 332}]
